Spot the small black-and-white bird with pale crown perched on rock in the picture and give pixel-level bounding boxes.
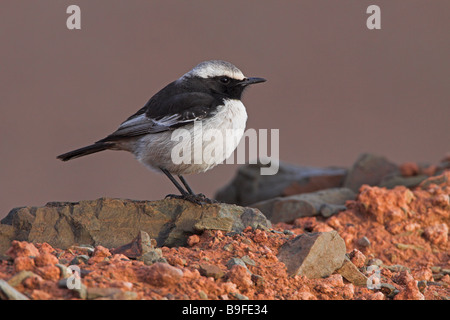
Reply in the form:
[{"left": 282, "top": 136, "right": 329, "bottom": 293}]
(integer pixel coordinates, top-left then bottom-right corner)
[{"left": 57, "top": 60, "right": 266, "bottom": 204}]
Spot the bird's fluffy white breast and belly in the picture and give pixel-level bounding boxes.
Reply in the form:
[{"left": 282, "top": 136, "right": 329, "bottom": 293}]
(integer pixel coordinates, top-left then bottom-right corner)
[{"left": 135, "top": 99, "right": 247, "bottom": 175}]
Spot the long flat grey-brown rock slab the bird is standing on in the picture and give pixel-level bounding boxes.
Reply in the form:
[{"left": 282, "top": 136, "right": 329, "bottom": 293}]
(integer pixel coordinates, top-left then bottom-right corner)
[{"left": 0, "top": 198, "right": 271, "bottom": 255}]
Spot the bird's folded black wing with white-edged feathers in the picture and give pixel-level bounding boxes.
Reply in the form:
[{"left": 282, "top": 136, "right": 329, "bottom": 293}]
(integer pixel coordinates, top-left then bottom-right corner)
[{"left": 98, "top": 92, "right": 221, "bottom": 142}]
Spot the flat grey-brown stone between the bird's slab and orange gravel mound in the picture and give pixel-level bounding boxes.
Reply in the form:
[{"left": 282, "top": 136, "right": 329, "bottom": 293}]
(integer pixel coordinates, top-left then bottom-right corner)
[{"left": 251, "top": 188, "right": 356, "bottom": 223}]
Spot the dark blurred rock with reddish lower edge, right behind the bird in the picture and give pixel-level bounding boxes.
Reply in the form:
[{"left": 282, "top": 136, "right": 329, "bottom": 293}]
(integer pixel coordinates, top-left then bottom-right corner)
[{"left": 215, "top": 163, "right": 347, "bottom": 206}]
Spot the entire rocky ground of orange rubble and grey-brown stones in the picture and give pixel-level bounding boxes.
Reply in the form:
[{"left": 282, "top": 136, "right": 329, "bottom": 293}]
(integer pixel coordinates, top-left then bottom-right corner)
[{"left": 0, "top": 155, "right": 450, "bottom": 300}]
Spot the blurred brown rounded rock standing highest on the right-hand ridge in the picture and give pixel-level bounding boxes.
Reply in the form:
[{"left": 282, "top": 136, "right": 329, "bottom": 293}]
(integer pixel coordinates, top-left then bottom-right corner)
[{"left": 343, "top": 153, "right": 399, "bottom": 192}]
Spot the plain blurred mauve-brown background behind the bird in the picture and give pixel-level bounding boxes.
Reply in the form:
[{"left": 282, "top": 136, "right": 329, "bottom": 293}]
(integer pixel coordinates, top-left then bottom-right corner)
[{"left": 0, "top": 0, "right": 450, "bottom": 217}]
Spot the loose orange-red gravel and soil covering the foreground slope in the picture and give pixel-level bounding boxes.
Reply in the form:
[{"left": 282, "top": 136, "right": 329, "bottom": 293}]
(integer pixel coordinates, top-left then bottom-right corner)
[{"left": 0, "top": 171, "right": 450, "bottom": 300}]
